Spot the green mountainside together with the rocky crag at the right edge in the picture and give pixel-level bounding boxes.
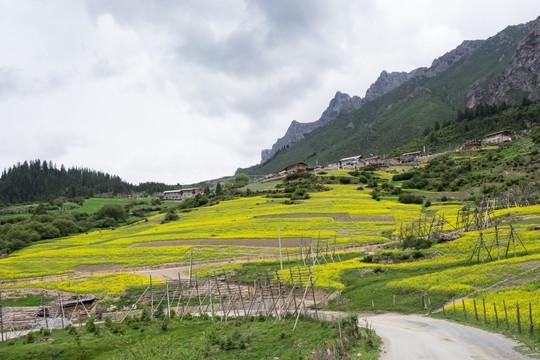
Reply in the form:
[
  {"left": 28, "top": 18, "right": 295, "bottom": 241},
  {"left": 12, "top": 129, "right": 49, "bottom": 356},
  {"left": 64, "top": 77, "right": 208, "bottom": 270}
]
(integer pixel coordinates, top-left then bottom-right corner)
[{"left": 239, "top": 19, "right": 540, "bottom": 174}]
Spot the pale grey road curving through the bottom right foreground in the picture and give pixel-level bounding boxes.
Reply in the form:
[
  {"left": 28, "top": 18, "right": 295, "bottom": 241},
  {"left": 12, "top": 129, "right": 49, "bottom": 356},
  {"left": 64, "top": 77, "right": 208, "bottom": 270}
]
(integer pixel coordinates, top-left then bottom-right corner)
[{"left": 359, "top": 313, "right": 531, "bottom": 360}]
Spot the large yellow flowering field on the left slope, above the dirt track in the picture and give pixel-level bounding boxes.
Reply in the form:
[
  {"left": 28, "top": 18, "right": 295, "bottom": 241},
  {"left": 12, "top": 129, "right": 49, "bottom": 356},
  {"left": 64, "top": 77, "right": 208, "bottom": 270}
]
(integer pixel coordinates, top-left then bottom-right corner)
[{"left": 0, "top": 185, "right": 430, "bottom": 279}]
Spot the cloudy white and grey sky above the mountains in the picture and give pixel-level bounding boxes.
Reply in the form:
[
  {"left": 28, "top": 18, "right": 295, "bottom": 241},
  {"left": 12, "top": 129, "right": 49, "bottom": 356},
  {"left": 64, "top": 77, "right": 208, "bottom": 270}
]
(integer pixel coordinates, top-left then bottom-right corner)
[{"left": 0, "top": 0, "right": 540, "bottom": 184}]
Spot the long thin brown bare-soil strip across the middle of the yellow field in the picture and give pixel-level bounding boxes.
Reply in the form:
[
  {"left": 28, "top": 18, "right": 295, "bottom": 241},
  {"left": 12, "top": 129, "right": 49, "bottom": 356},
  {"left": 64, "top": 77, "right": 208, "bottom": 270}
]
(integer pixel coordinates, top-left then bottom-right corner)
[{"left": 130, "top": 238, "right": 305, "bottom": 248}]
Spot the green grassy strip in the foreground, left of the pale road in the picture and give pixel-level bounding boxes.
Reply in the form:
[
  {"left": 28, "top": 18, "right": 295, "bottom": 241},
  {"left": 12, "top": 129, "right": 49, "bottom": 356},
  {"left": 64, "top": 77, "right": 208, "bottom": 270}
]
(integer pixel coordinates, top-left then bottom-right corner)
[{"left": 0, "top": 316, "right": 380, "bottom": 360}]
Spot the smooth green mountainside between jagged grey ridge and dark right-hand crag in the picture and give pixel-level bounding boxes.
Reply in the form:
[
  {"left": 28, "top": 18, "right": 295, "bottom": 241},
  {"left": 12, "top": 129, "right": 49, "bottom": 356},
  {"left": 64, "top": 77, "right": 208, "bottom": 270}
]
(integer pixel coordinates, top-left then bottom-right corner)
[{"left": 244, "top": 22, "right": 526, "bottom": 174}]
